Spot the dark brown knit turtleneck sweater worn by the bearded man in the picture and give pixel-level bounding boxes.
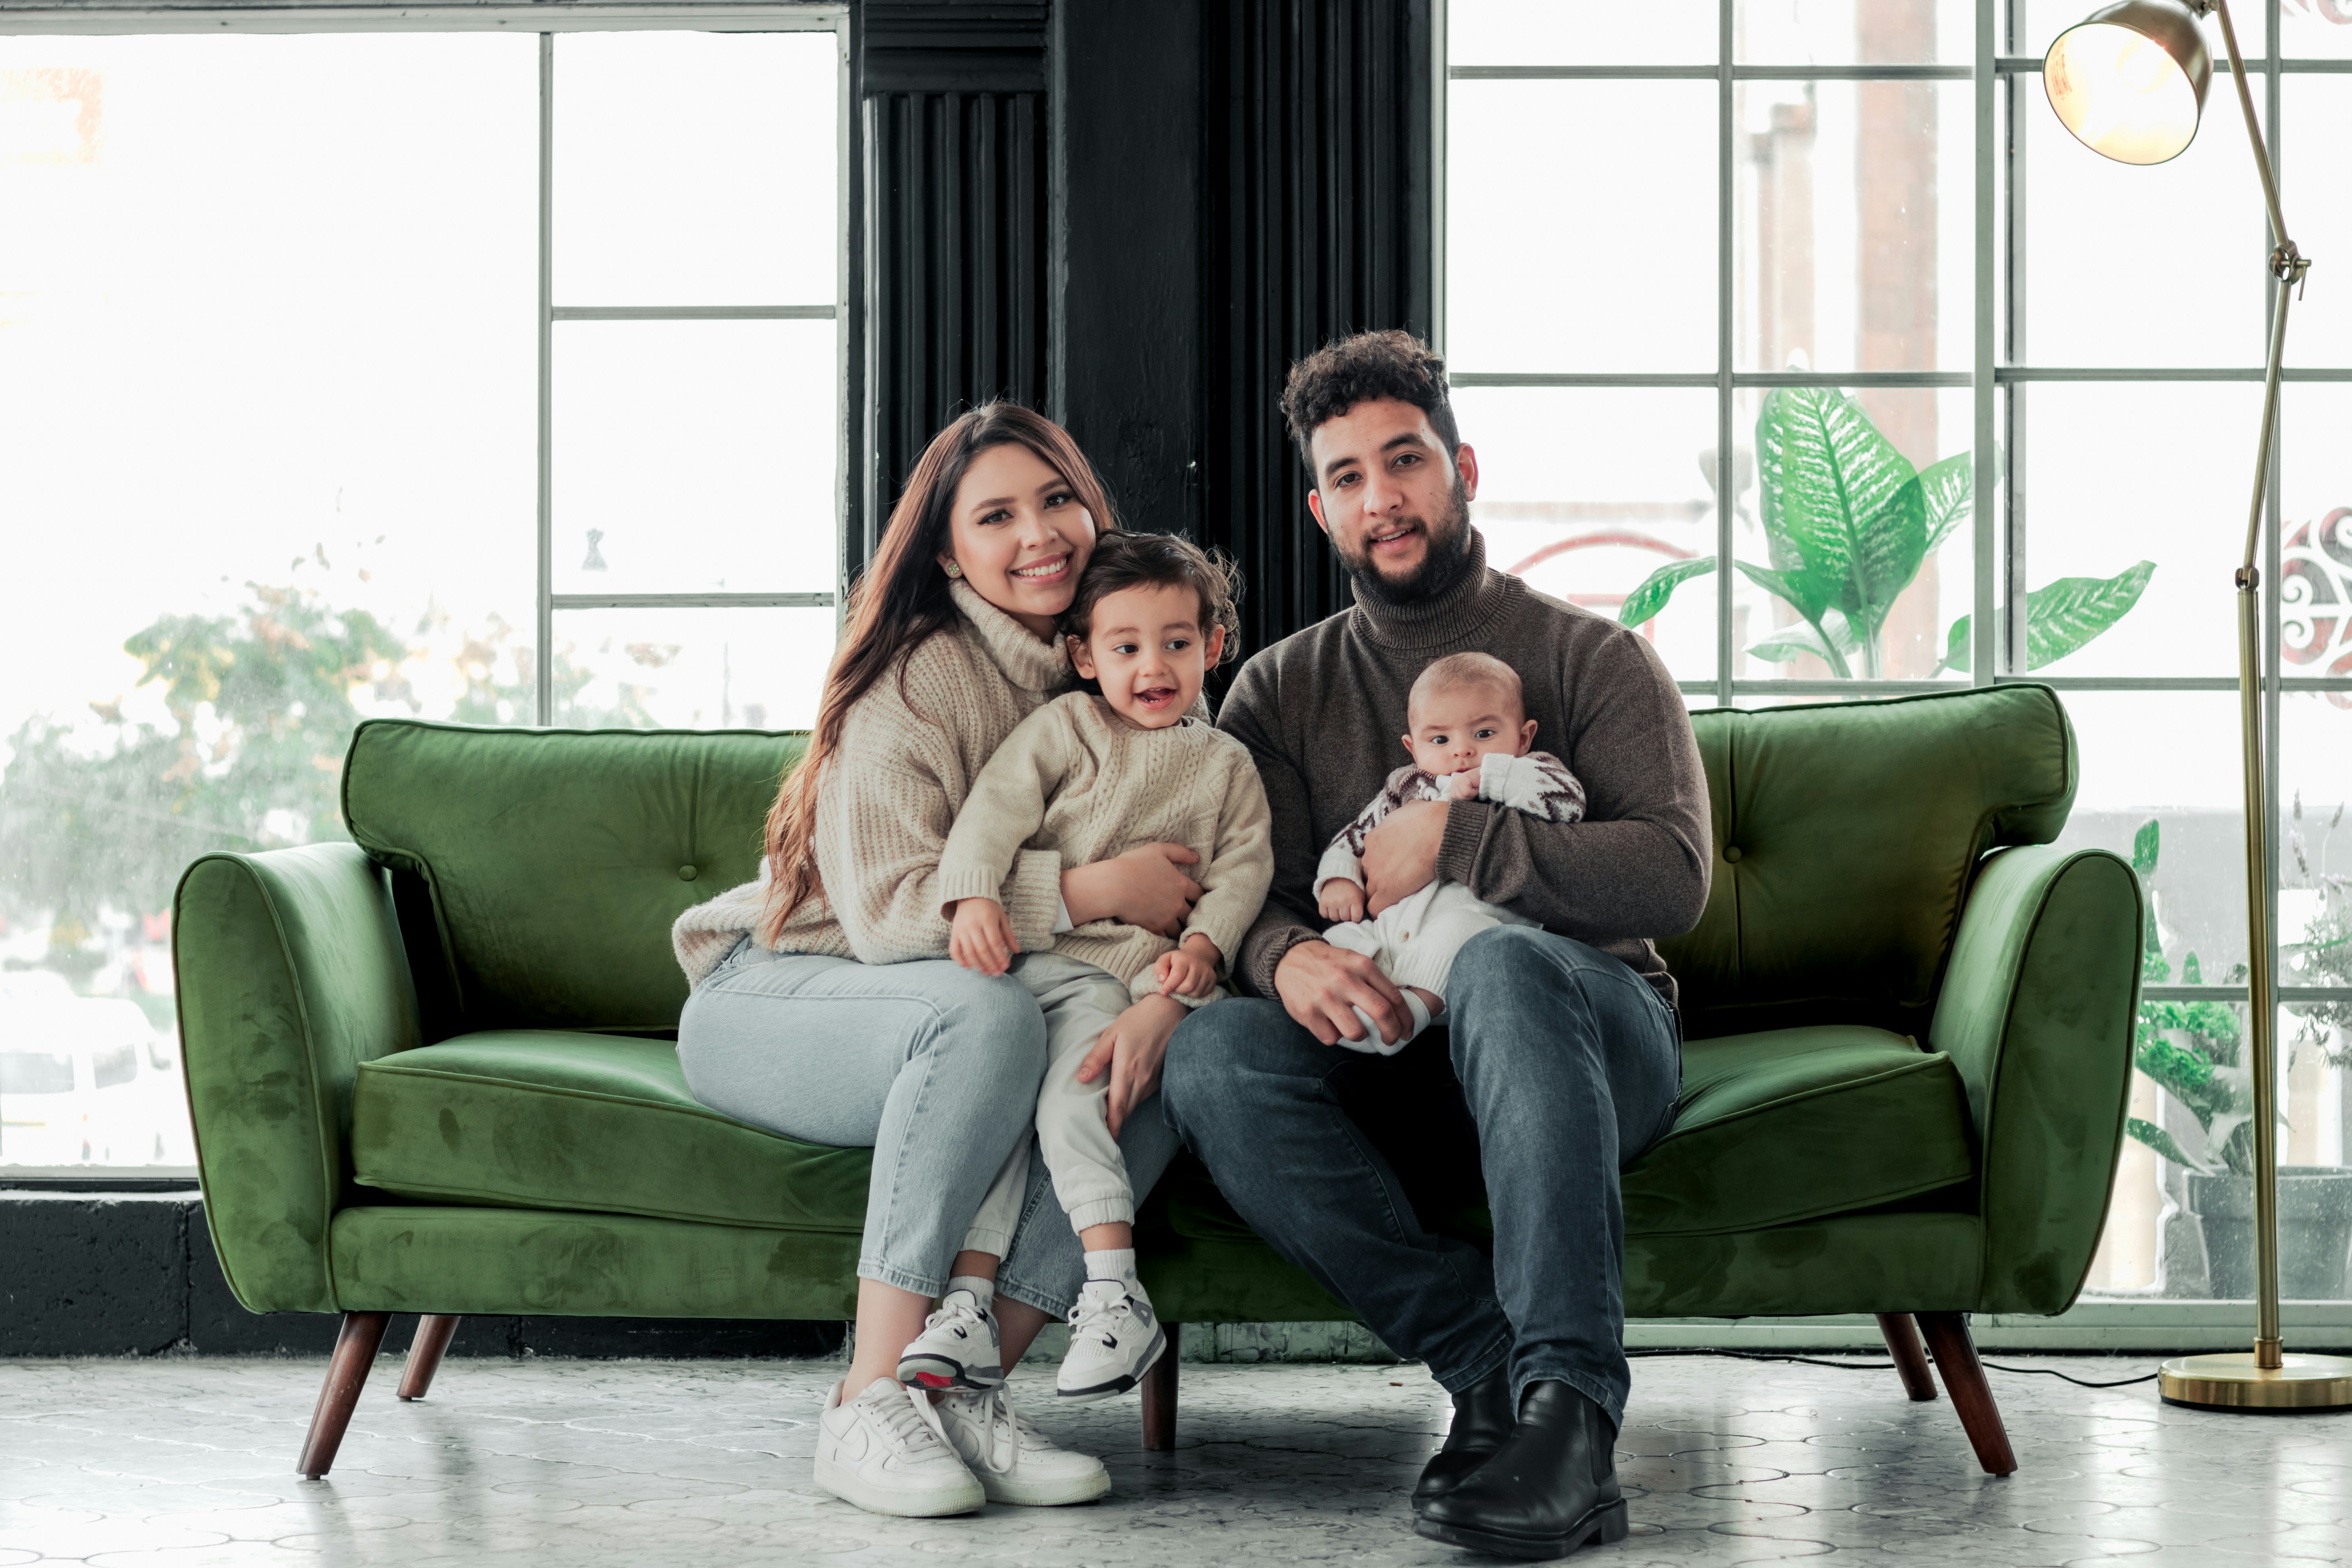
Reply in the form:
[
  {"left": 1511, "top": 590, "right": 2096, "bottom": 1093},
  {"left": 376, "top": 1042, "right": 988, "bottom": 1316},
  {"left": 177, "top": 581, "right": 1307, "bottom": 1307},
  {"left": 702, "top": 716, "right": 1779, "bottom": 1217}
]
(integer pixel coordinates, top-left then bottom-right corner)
[{"left": 1218, "top": 529, "right": 1715, "bottom": 1001}]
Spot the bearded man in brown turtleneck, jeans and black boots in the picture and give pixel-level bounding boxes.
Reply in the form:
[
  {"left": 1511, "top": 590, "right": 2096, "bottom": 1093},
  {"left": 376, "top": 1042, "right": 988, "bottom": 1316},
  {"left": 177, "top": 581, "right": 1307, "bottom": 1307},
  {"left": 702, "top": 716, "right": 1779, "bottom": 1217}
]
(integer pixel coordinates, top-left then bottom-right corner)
[{"left": 1164, "top": 331, "right": 1712, "bottom": 1559}]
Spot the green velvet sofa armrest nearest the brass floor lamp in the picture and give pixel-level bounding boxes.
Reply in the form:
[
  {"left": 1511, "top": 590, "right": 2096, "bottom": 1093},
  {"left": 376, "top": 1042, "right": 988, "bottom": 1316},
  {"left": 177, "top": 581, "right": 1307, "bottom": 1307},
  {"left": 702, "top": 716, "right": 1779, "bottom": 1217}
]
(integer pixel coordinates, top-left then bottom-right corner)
[{"left": 1928, "top": 846, "right": 2140, "bottom": 1312}]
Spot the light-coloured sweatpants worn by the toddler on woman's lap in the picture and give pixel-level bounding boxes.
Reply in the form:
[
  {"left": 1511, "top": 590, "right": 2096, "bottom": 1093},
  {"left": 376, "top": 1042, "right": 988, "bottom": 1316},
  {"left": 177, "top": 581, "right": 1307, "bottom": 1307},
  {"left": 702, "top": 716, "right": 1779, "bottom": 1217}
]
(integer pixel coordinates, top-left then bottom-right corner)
[{"left": 964, "top": 952, "right": 1136, "bottom": 1258}]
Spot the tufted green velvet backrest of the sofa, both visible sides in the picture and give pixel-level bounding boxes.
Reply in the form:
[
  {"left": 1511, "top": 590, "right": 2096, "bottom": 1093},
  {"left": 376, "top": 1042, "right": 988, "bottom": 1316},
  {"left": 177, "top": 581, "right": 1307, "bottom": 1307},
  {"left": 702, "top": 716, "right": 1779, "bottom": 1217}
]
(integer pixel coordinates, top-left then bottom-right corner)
[{"left": 343, "top": 684, "right": 2075, "bottom": 1039}]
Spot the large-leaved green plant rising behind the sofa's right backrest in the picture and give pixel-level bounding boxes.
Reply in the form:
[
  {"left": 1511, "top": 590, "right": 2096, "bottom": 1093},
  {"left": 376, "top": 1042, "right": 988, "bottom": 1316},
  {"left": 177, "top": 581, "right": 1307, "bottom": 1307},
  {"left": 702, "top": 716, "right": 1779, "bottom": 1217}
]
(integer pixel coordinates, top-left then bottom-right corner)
[{"left": 1618, "top": 386, "right": 2157, "bottom": 680}]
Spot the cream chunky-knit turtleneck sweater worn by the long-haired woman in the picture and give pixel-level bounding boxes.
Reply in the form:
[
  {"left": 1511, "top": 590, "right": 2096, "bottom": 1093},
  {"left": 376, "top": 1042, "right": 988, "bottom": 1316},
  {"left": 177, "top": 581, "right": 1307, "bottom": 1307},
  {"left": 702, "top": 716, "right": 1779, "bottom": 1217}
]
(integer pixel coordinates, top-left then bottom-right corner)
[{"left": 670, "top": 581, "right": 1077, "bottom": 985}]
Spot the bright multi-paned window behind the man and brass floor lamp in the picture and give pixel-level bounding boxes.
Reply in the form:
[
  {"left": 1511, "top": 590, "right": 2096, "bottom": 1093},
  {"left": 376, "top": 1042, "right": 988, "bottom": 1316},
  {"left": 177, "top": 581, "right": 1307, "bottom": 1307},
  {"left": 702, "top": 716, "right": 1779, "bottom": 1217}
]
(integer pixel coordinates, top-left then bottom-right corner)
[{"left": 1439, "top": 0, "right": 2352, "bottom": 1300}]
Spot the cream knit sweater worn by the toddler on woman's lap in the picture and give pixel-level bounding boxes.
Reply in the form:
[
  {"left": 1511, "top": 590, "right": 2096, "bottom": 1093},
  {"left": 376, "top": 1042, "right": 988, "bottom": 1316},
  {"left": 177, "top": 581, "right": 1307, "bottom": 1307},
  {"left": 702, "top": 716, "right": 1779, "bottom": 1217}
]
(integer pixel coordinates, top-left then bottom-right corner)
[{"left": 938, "top": 691, "right": 1275, "bottom": 997}]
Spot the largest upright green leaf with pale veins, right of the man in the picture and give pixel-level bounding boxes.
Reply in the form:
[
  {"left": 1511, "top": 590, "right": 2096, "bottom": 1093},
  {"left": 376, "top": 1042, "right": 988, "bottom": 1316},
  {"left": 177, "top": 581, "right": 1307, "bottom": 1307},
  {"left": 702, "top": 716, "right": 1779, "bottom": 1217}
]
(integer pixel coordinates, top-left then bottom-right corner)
[{"left": 1757, "top": 386, "right": 1926, "bottom": 637}]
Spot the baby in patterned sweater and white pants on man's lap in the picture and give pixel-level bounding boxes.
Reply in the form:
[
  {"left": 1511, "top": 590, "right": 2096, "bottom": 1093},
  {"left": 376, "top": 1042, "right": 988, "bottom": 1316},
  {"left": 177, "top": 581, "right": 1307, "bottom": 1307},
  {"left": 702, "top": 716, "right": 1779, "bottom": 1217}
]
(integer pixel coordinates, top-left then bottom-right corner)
[{"left": 1315, "top": 653, "right": 1585, "bottom": 1056}]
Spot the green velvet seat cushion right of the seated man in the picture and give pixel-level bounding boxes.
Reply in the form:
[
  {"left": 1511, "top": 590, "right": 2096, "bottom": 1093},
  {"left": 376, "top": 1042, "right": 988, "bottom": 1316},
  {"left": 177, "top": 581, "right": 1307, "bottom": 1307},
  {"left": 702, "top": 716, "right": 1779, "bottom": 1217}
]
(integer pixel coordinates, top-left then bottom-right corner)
[{"left": 1150, "top": 1025, "right": 1976, "bottom": 1241}]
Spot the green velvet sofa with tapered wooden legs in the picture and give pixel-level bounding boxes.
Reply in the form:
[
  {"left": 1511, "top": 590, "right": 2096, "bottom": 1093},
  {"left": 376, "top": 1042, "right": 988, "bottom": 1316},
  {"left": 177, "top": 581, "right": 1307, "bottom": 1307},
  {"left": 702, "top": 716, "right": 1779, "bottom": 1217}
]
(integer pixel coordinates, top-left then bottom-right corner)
[{"left": 172, "top": 684, "right": 2140, "bottom": 1474}]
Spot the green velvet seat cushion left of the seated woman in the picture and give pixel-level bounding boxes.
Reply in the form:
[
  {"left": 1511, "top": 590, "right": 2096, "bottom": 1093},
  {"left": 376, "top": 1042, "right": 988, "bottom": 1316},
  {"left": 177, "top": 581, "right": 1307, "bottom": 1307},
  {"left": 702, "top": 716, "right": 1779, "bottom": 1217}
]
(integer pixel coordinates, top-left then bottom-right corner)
[{"left": 350, "top": 1030, "right": 873, "bottom": 1232}]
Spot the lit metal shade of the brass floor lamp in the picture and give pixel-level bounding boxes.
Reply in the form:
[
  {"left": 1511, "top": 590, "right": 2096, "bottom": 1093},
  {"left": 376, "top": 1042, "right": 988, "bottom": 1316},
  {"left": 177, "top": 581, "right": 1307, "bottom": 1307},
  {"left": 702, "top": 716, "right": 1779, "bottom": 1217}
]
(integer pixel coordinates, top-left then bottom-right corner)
[{"left": 2041, "top": 0, "right": 2213, "bottom": 165}]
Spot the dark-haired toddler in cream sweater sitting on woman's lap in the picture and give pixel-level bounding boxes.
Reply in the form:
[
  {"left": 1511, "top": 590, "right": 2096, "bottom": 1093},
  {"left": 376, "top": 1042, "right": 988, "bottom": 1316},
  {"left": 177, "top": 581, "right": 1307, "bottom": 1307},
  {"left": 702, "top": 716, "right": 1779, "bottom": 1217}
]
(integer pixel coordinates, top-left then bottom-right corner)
[{"left": 898, "top": 534, "right": 1275, "bottom": 1403}]
